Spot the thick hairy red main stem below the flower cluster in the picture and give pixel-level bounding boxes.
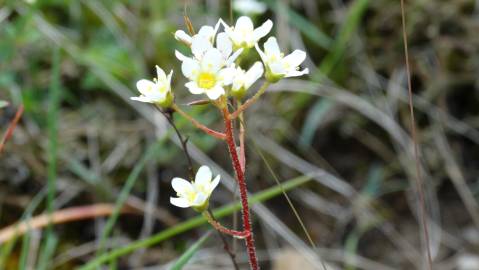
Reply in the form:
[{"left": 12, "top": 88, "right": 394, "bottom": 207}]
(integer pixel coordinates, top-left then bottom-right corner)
[{"left": 223, "top": 106, "right": 259, "bottom": 270}]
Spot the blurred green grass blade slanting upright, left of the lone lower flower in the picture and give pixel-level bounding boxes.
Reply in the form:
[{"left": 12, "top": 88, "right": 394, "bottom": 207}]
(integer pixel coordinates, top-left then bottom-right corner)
[{"left": 97, "top": 142, "right": 161, "bottom": 256}]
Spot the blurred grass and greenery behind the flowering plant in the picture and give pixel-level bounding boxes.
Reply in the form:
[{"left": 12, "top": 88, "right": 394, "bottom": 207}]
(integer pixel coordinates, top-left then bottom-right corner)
[{"left": 0, "top": 0, "right": 479, "bottom": 270}]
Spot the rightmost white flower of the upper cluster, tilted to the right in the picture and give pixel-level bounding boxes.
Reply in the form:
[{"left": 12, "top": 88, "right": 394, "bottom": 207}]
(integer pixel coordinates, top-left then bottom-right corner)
[{"left": 255, "top": 37, "right": 309, "bottom": 82}]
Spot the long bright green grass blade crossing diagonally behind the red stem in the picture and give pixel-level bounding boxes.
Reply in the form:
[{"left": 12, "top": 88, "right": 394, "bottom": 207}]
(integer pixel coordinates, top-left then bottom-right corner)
[{"left": 79, "top": 176, "right": 311, "bottom": 270}]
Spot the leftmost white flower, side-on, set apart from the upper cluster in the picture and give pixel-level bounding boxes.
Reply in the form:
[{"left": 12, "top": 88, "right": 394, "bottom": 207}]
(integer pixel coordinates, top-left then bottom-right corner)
[{"left": 131, "top": 66, "right": 173, "bottom": 107}]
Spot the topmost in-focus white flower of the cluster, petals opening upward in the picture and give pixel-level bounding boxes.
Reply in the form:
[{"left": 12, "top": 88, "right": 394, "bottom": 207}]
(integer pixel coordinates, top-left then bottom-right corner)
[{"left": 221, "top": 16, "right": 273, "bottom": 48}]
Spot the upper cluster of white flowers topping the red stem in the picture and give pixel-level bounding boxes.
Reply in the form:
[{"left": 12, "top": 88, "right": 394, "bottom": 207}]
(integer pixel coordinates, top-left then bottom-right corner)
[{"left": 132, "top": 16, "right": 308, "bottom": 107}]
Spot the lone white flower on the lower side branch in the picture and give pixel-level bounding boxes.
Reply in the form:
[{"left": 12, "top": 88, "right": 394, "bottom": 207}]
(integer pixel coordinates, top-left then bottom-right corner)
[{"left": 170, "top": 166, "right": 220, "bottom": 212}]
